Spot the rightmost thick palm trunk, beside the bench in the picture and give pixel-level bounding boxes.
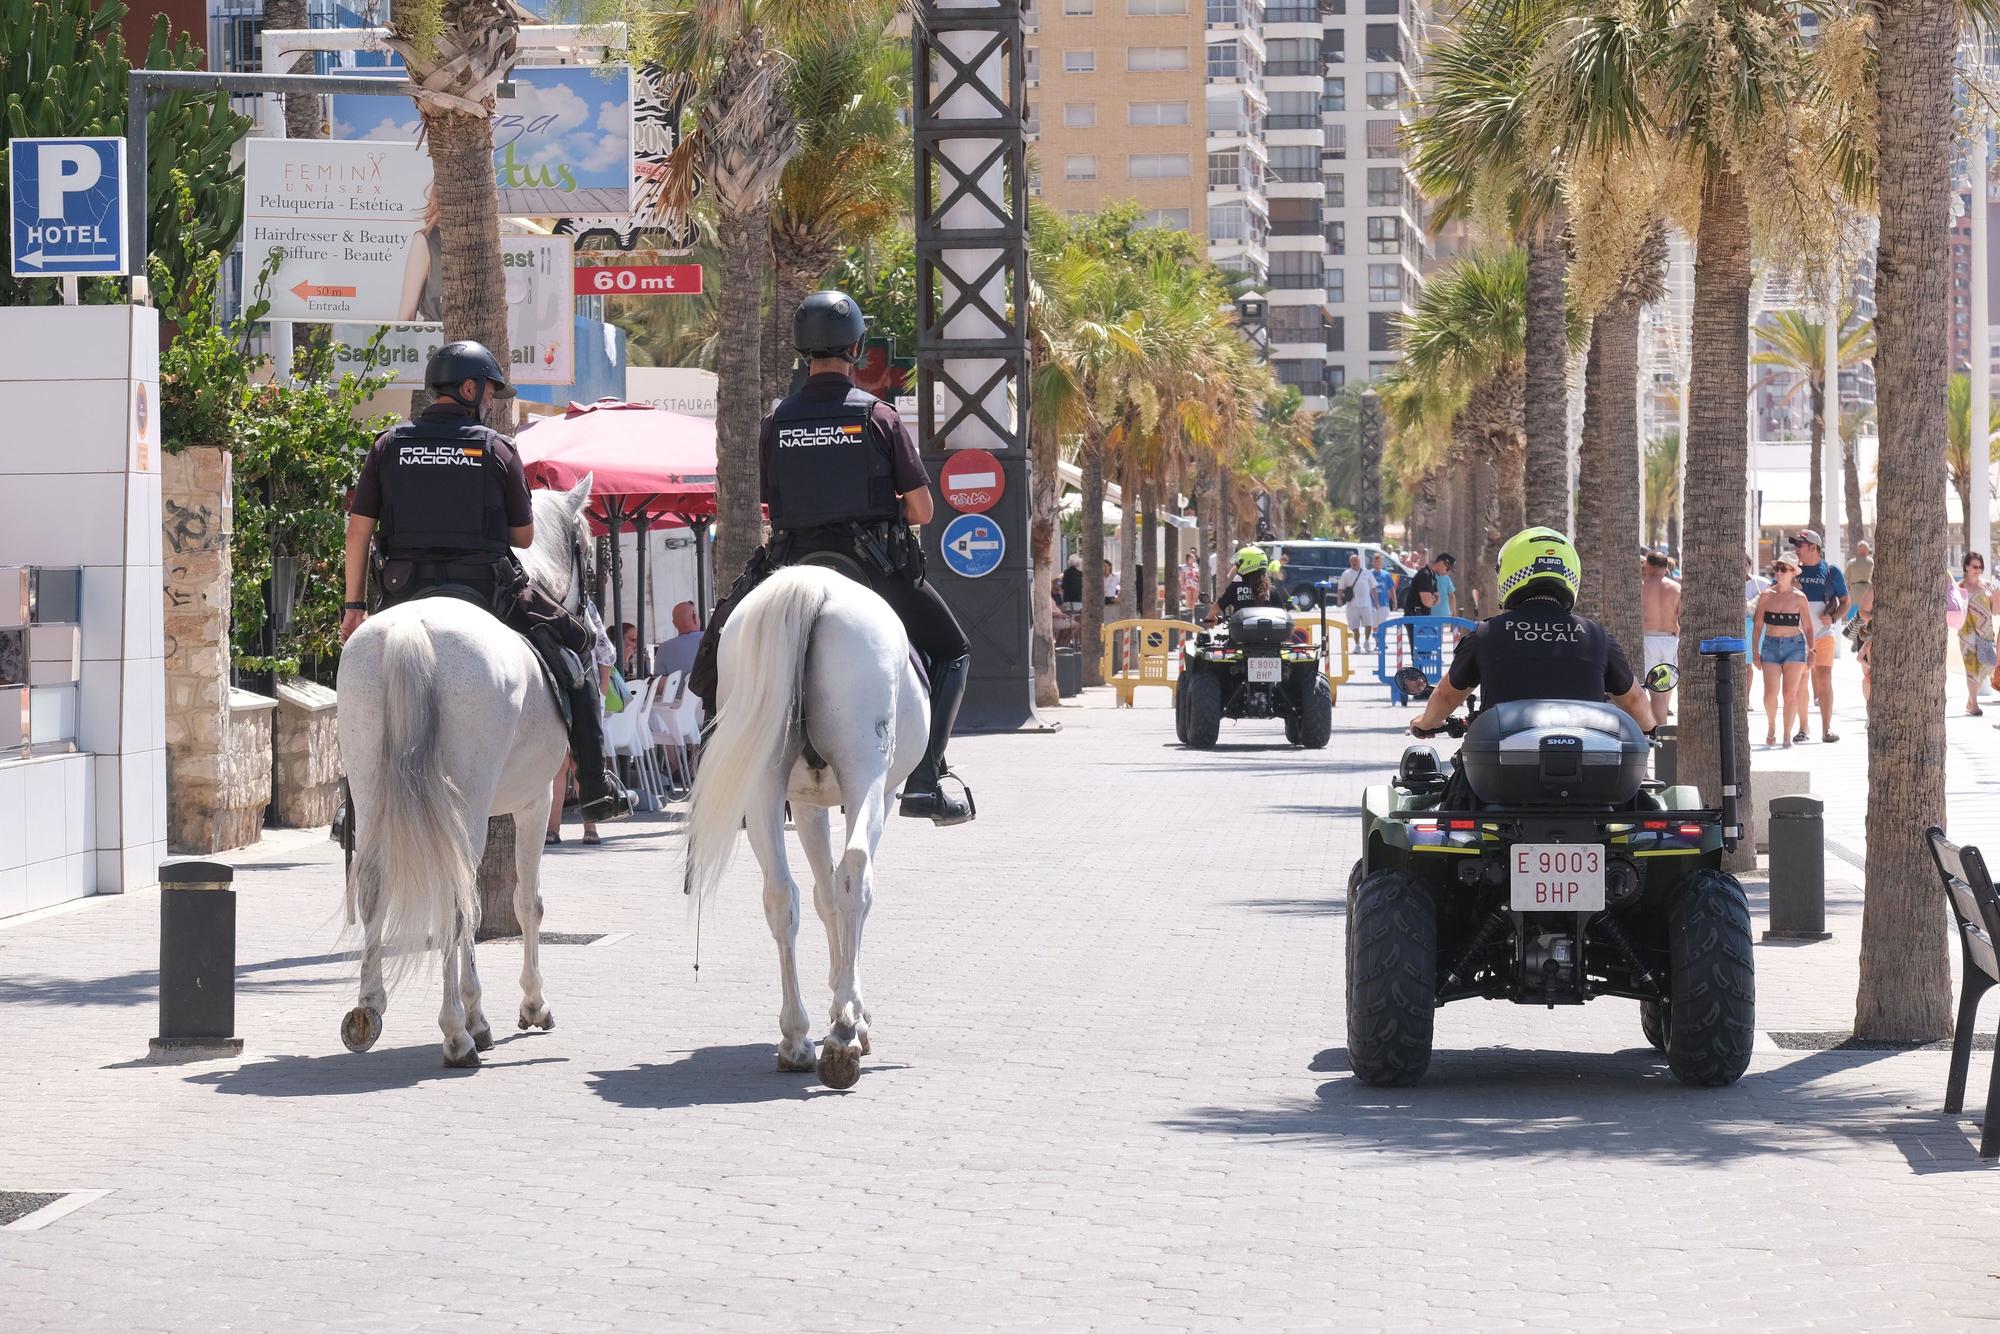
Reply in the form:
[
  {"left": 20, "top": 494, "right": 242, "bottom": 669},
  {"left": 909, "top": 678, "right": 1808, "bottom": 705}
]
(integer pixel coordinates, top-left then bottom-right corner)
[{"left": 1854, "top": 0, "right": 1952, "bottom": 1038}]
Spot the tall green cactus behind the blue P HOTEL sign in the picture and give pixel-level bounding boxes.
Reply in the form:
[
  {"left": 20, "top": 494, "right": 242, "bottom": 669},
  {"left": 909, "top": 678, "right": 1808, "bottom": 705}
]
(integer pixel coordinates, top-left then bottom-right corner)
[{"left": 0, "top": 0, "right": 250, "bottom": 306}]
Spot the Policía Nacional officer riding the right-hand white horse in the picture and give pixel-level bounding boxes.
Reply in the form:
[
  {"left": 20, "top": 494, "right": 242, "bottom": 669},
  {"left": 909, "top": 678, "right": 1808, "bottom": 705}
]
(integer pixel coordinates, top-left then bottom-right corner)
[{"left": 688, "top": 292, "right": 972, "bottom": 824}]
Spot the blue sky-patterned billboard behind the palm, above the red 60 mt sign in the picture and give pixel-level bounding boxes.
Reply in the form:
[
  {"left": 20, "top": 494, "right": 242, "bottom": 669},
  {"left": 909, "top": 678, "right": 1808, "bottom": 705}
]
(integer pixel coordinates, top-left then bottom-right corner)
[{"left": 332, "top": 64, "right": 634, "bottom": 218}]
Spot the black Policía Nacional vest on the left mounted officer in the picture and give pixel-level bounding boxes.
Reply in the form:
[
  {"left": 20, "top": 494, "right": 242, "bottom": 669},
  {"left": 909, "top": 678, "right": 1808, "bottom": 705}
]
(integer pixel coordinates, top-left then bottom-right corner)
[{"left": 382, "top": 418, "right": 510, "bottom": 556}]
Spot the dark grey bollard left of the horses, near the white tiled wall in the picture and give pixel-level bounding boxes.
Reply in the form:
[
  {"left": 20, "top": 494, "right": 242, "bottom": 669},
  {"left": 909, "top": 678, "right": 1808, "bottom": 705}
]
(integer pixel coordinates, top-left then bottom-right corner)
[{"left": 148, "top": 862, "right": 244, "bottom": 1062}]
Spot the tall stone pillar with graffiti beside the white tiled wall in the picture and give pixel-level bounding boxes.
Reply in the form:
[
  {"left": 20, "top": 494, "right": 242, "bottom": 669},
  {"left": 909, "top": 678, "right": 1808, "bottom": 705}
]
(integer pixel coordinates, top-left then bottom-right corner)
[{"left": 160, "top": 448, "right": 235, "bottom": 852}]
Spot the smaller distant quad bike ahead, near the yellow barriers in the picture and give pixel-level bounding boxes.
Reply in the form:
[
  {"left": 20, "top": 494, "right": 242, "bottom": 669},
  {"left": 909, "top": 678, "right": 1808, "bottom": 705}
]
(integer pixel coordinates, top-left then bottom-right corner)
[{"left": 1174, "top": 606, "right": 1334, "bottom": 750}]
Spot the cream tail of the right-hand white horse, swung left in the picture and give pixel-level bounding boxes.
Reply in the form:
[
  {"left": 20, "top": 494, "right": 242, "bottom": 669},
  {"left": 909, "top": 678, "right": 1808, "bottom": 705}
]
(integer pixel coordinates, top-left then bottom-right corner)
[{"left": 686, "top": 570, "right": 828, "bottom": 898}]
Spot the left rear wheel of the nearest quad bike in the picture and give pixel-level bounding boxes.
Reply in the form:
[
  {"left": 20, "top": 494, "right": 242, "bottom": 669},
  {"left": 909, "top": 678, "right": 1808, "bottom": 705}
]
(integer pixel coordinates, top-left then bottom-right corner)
[{"left": 1348, "top": 870, "right": 1438, "bottom": 1088}]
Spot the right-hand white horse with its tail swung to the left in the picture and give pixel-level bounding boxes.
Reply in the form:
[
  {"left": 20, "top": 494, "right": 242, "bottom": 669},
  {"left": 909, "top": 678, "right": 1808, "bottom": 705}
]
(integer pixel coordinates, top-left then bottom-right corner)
[{"left": 686, "top": 564, "right": 930, "bottom": 1088}]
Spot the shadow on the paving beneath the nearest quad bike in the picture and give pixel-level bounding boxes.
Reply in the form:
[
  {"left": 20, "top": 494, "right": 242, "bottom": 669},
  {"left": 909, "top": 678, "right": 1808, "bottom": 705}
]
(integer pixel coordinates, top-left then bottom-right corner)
[{"left": 1166, "top": 1046, "right": 1988, "bottom": 1174}]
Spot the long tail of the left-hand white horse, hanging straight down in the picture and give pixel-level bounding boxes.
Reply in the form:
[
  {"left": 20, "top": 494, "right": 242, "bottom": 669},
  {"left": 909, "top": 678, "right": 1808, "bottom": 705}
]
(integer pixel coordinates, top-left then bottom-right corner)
[{"left": 356, "top": 616, "right": 480, "bottom": 972}]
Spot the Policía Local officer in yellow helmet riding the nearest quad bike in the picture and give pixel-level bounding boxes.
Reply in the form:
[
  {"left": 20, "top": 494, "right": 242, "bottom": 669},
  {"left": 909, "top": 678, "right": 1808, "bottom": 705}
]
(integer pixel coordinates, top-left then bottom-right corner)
[{"left": 1410, "top": 528, "right": 1652, "bottom": 736}]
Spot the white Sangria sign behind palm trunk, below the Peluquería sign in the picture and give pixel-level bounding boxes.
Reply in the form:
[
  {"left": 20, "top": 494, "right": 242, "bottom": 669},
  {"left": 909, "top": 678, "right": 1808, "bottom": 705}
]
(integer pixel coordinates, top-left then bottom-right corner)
[{"left": 334, "top": 236, "right": 576, "bottom": 388}]
